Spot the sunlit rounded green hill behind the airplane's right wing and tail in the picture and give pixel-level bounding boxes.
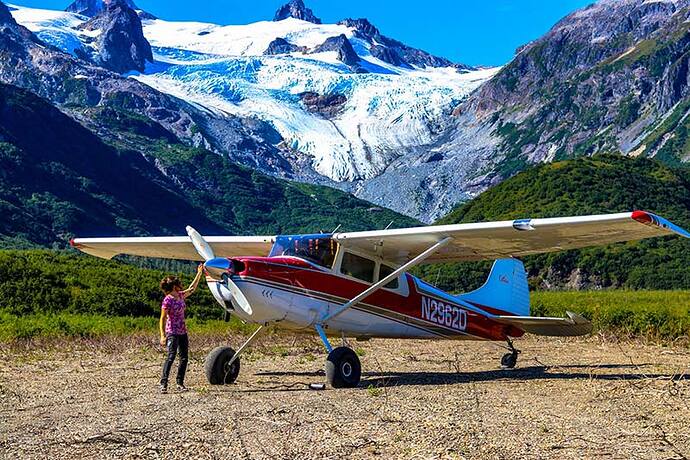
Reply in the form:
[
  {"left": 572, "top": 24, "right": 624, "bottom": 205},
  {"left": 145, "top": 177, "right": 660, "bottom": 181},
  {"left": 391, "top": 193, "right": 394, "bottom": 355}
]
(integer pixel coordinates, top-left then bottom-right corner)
[{"left": 421, "top": 156, "right": 690, "bottom": 291}]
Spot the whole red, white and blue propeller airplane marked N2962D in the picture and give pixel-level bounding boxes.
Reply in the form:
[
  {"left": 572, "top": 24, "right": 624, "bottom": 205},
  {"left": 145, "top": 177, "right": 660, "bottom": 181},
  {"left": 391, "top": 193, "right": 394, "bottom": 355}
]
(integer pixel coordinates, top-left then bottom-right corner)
[{"left": 71, "top": 211, "right": 690, "bottom": 388}]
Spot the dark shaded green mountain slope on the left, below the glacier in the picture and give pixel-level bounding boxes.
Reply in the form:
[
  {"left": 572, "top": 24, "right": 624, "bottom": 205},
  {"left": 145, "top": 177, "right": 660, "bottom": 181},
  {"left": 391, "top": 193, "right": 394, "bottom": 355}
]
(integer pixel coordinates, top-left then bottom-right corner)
[{"left": 0, "top": 84, "right": 418, "bottom": 248}]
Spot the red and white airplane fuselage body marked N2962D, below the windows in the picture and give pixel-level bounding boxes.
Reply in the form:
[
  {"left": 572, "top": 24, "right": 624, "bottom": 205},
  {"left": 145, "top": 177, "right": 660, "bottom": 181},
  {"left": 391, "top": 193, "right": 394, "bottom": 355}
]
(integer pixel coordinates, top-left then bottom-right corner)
[{"left": 208, "top": 256, "right": 522, "bottom": 340}]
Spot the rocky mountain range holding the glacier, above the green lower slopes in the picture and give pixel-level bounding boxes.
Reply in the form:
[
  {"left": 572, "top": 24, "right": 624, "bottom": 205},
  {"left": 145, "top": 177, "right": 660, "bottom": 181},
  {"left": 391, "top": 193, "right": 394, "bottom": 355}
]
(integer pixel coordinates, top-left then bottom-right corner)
[{"left": 0, "top": 0, "right": 690, "bottom": 222}]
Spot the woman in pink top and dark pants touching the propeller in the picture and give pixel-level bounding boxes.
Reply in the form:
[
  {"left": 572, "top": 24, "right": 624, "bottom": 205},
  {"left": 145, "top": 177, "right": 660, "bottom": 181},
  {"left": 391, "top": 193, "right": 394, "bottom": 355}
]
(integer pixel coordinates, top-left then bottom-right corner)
[{"left": 159, "top": 265, "right": 204, "bottom": 393}]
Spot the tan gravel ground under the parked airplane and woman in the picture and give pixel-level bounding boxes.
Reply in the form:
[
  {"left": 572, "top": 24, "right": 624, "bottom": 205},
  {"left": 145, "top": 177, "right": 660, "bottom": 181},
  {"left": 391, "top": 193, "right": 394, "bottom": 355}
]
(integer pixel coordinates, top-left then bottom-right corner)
[{"left": 0, "top": 336, "right": 690, "bottom": 459}]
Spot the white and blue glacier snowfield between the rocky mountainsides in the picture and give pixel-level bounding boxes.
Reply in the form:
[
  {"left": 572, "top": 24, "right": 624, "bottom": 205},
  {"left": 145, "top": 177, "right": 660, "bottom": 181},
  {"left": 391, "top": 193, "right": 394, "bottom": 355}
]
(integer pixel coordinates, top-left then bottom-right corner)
[{"left": 12, "top": 0, "right": 496, "bottom": 218}]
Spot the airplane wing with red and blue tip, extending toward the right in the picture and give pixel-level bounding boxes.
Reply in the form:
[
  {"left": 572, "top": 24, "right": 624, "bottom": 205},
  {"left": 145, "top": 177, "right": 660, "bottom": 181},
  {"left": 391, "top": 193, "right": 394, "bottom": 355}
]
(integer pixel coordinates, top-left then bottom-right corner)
[{"left": 333, "top": 211, "right": 690, "bottom": 264}]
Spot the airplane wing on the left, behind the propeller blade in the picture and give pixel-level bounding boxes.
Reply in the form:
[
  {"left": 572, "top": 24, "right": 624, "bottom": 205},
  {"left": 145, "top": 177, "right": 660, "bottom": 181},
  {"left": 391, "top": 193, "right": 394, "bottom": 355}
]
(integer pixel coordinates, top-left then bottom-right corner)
[{"left": 70, "top": 236, "right": 275, "bottom": 260}]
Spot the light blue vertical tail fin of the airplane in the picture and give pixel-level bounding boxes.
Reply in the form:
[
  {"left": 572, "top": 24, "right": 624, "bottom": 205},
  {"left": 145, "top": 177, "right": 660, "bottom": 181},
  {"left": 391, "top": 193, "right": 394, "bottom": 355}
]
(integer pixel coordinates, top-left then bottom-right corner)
[{"left": 458, "top": 259, "right": 529, "bottom": 316}]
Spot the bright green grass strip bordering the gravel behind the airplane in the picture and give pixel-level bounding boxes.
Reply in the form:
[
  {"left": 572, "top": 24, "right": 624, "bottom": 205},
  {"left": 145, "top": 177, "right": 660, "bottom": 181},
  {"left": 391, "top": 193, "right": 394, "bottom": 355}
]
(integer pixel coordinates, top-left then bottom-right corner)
[{"left": 0, "top": 291, "right": 690, "bottom": 342}]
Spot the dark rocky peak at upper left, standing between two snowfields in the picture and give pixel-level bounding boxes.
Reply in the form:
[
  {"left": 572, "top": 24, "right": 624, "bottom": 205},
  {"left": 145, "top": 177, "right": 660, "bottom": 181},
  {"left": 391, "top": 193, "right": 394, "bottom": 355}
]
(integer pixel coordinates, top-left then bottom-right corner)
[{"left": 82, "top": 0, "right": 153, "bottom": 73}]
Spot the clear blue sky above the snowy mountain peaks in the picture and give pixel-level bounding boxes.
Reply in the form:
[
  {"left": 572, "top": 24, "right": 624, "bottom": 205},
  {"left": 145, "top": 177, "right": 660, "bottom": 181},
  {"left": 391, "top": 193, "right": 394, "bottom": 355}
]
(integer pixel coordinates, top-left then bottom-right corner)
[{"left": 9, "top": 0, "right": 593, "bottom": 65}]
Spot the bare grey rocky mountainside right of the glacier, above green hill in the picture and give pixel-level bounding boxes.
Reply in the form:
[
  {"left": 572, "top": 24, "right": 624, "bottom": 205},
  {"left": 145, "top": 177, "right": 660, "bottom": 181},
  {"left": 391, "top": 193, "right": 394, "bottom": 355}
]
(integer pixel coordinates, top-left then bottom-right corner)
[{"left": 459, "top": 0, "right": 690, "bottom": 175}]
